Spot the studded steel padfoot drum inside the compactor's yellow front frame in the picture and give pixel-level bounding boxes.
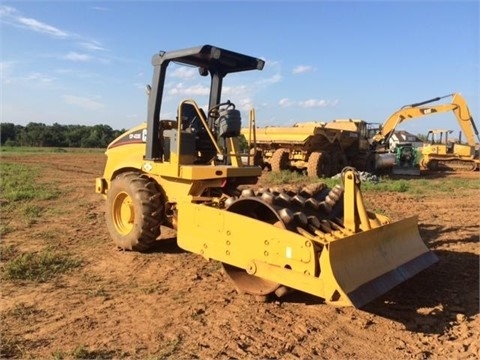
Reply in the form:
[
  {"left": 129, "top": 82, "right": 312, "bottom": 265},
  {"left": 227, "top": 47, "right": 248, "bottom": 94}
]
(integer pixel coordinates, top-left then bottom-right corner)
[{"left": 222, "top": 183, "right": 344, "bottom": 297}]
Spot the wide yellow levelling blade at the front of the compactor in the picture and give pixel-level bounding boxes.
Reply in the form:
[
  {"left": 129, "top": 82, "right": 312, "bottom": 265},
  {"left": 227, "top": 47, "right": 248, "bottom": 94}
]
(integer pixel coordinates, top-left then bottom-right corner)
[{"left": 320, "top": 216, "right": 438, "bottom": 308}]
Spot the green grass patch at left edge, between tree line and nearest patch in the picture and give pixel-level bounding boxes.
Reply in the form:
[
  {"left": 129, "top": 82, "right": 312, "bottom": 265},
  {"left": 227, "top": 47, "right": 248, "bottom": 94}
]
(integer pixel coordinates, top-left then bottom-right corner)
[{"left": 0, "top": 163, "right": 59, "bottom": 203}]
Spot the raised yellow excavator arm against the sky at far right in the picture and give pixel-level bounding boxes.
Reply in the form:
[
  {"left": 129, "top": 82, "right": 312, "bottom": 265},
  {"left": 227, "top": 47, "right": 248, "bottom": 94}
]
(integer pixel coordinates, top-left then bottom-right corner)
[{"left": 372, "top": 93, "right": 480, "bottom": 147}]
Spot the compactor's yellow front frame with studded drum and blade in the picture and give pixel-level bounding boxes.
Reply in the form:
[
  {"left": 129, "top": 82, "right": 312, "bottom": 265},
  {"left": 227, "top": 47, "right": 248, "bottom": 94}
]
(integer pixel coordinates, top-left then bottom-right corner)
[{"left": 177, "top": 170, "right": 438, "bottom": 307}]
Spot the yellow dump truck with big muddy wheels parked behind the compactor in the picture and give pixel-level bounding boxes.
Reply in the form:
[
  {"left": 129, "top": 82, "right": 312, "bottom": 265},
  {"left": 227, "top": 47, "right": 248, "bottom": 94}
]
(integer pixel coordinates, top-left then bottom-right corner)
[{"left": 241, "top": 119, "right": 386, "bottom": 177}]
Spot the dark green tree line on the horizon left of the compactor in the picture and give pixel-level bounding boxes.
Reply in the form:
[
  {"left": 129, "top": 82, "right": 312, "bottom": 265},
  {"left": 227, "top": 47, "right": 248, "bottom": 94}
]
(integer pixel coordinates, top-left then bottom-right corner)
[{"left": 0, "top": 122, "right": 125, "bottom": 148}]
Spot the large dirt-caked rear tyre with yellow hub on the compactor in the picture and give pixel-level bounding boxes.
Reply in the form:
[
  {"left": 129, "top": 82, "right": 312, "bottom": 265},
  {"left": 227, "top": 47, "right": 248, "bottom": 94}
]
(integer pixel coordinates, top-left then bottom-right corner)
[{"left": 106, "top": 172, "right": 163, "bottom": 251}]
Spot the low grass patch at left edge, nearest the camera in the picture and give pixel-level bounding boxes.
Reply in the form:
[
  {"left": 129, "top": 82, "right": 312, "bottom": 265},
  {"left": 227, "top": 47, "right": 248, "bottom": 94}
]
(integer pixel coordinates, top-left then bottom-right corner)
[{"left": 3, "top": 249, "right": 81, "bottom": 282}]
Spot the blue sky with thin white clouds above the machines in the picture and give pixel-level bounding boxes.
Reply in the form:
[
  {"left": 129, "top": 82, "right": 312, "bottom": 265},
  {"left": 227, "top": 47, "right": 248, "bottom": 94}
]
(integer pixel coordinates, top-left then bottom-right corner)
[{"left": 0, "top": 0, "right": 480, "bottom": 134}]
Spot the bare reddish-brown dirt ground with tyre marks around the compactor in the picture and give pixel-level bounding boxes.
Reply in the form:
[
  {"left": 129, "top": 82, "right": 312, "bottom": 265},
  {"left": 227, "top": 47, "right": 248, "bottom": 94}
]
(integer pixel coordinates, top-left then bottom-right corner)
[{"left": 0, "top": 153, "right": 480, "bottom": 359}]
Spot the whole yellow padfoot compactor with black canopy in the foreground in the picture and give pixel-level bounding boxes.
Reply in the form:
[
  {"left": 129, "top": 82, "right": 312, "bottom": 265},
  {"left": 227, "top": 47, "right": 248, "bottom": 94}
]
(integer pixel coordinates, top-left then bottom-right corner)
[{"left": 96, "top": 45, "right": 437, "bottom": 307}]
